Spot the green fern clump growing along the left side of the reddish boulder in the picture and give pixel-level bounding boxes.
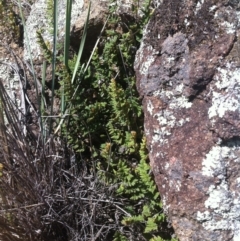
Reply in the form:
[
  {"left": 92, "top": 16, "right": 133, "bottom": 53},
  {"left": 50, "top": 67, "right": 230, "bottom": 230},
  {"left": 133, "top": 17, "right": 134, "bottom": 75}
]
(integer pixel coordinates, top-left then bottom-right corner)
[{"left": 35, "top": 0, "right": 176, "bottom": 241}]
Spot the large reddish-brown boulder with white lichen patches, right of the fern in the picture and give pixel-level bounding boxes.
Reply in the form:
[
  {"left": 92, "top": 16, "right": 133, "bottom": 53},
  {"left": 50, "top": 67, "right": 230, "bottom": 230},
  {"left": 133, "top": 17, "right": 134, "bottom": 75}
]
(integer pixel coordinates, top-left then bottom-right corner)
[{"left": 135, "top": 0, "right": 240, "bottom": 241}]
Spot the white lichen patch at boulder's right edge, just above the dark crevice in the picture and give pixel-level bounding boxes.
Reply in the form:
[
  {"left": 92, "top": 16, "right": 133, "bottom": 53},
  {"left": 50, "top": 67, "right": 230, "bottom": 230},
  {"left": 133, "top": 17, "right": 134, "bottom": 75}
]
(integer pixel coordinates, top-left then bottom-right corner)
[{"left": 208, "top": 65, "right": 240, "bottom": 119}]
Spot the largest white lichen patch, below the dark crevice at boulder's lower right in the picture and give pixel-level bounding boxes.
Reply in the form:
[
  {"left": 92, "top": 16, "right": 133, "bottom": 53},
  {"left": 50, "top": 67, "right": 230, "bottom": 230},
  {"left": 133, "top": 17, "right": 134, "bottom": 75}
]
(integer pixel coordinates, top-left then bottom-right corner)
[{"left": 196, "top": 146, "right": 240, "bottom": 241}]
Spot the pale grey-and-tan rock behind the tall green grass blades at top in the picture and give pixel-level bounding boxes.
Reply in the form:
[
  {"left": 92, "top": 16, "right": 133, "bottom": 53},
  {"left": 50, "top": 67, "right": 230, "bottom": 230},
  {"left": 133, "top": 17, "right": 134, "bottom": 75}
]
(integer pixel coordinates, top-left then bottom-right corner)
[{"left": 24, "top": 0, "right": 144, "bottom": 63}]
